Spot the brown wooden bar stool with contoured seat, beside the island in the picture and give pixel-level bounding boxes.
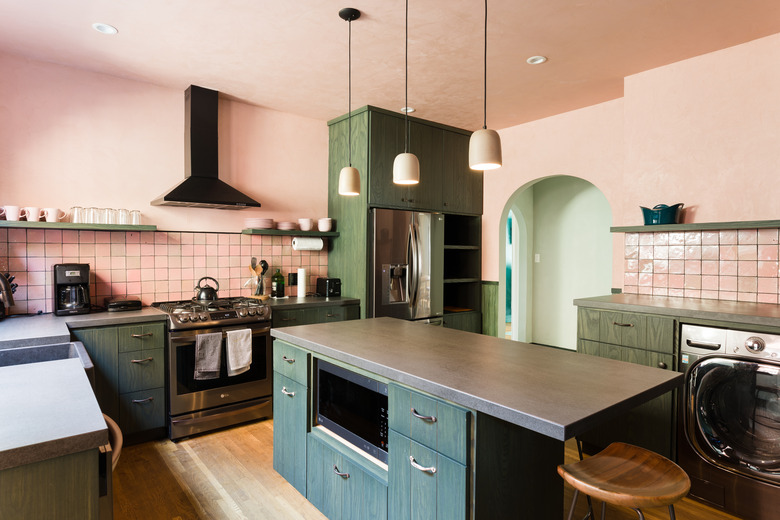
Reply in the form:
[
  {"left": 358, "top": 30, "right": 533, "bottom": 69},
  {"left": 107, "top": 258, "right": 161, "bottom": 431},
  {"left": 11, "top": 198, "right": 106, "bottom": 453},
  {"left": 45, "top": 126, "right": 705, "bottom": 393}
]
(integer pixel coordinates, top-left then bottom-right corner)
[{"left": 558, "top": 442, "right": 691, "bottom": 520}]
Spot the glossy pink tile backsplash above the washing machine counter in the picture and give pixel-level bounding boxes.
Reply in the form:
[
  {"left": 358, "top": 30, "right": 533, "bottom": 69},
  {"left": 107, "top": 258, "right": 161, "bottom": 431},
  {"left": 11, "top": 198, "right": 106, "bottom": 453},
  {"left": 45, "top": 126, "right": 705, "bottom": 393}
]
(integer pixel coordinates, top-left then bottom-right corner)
[{"left": 623, "top": 228, "right": 780, "bottom": 304}]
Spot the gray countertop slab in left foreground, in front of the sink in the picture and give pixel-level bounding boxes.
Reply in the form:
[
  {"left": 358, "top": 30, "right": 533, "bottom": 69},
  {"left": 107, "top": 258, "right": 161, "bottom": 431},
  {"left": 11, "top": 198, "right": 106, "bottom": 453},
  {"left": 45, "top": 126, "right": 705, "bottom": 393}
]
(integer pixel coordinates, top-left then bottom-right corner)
[{"left": 0, "top": 359, "right": 108, "bottom": 470}]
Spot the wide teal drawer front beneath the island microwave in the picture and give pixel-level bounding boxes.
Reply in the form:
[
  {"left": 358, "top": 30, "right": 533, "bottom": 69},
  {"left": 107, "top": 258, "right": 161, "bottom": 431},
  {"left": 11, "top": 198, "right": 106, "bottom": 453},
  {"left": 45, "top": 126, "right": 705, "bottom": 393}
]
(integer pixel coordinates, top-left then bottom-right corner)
[{"left": 306, "top": 434, "right": 387, "bottom": 520}]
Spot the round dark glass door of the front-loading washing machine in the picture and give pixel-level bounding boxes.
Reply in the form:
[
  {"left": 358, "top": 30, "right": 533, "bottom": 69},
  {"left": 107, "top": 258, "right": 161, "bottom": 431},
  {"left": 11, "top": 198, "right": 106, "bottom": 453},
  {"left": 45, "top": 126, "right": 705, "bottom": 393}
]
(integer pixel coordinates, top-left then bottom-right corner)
[{"left": 685, "top": 356, "right": 780, "bottom": 484}]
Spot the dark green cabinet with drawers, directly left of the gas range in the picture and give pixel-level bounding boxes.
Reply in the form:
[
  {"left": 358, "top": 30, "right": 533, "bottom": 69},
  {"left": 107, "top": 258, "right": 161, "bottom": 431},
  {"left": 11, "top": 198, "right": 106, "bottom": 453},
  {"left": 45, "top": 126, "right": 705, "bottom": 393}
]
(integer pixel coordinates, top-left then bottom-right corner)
[{"left": 72, "top": 322, "right": 165, "bottom": 440}]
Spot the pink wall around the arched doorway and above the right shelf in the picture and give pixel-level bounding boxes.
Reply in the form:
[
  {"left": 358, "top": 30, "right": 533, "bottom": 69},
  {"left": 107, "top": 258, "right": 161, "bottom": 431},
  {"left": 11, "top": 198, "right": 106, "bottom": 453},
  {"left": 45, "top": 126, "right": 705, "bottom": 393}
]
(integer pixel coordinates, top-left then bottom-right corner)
[{"left": 482, "top": 35, "right": 780, "bottom": 287}]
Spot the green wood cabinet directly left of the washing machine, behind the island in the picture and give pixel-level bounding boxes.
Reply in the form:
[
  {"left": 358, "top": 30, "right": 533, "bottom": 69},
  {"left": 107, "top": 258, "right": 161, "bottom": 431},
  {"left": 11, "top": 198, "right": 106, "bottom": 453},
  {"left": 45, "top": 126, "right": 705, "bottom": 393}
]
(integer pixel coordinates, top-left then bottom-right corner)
[{"left": 577, "top": 307, "right": 677, "bottom": 458}]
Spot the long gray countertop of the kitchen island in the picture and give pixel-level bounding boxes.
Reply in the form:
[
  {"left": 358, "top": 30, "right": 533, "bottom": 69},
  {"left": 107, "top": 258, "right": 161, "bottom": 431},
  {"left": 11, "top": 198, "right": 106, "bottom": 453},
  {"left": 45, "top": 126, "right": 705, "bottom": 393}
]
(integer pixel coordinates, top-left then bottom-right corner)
[{"left": 271, "top": 318, "right": 683, "bottom": 440}]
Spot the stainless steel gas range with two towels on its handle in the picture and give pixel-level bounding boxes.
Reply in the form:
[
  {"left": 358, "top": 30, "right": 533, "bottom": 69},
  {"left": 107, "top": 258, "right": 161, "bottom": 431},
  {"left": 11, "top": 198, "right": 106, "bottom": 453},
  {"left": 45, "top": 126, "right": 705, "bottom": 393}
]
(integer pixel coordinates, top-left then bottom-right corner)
[{"left": 152, "top": 297, "right": 273, "bottom": 440}]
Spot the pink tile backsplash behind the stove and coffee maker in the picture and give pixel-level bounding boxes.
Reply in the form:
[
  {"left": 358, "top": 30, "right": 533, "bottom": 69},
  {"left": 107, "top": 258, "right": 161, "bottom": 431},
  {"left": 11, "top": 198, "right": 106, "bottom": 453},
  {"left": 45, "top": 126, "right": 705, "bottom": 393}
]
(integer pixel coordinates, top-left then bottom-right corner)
[{"left": 0, "top": 228, "right": 328, "bottom": 314}]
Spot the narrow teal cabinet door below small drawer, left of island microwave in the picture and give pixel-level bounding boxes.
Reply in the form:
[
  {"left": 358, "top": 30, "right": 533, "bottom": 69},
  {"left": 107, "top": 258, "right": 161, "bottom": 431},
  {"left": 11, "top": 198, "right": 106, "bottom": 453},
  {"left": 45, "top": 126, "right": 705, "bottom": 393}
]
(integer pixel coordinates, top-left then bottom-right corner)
[{"left": 273, "top": 372, "right": 309, "bottom": 496}]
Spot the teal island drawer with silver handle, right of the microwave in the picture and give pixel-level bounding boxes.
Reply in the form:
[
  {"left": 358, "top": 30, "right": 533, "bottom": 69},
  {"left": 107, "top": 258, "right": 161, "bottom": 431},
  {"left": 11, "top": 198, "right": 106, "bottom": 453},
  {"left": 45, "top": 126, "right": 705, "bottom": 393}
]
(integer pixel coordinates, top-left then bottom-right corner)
[{"left": 388, "top": 384, "right": 470, "bottom": 464}]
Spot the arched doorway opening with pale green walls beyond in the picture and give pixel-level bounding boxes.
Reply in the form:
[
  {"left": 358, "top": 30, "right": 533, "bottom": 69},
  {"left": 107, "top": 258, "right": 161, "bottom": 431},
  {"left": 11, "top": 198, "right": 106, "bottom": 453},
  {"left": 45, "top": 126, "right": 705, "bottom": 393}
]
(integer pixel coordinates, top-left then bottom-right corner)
[{"left": 499, "top": 175, "right": 612, "bottom": 350}]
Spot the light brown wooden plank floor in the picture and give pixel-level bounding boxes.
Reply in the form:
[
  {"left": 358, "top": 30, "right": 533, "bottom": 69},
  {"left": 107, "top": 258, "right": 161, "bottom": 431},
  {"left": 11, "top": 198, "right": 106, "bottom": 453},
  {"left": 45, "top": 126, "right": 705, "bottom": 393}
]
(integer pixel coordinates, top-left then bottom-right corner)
[{"left": 114, "top": 420, "right": 738, "bottom": 520}]
